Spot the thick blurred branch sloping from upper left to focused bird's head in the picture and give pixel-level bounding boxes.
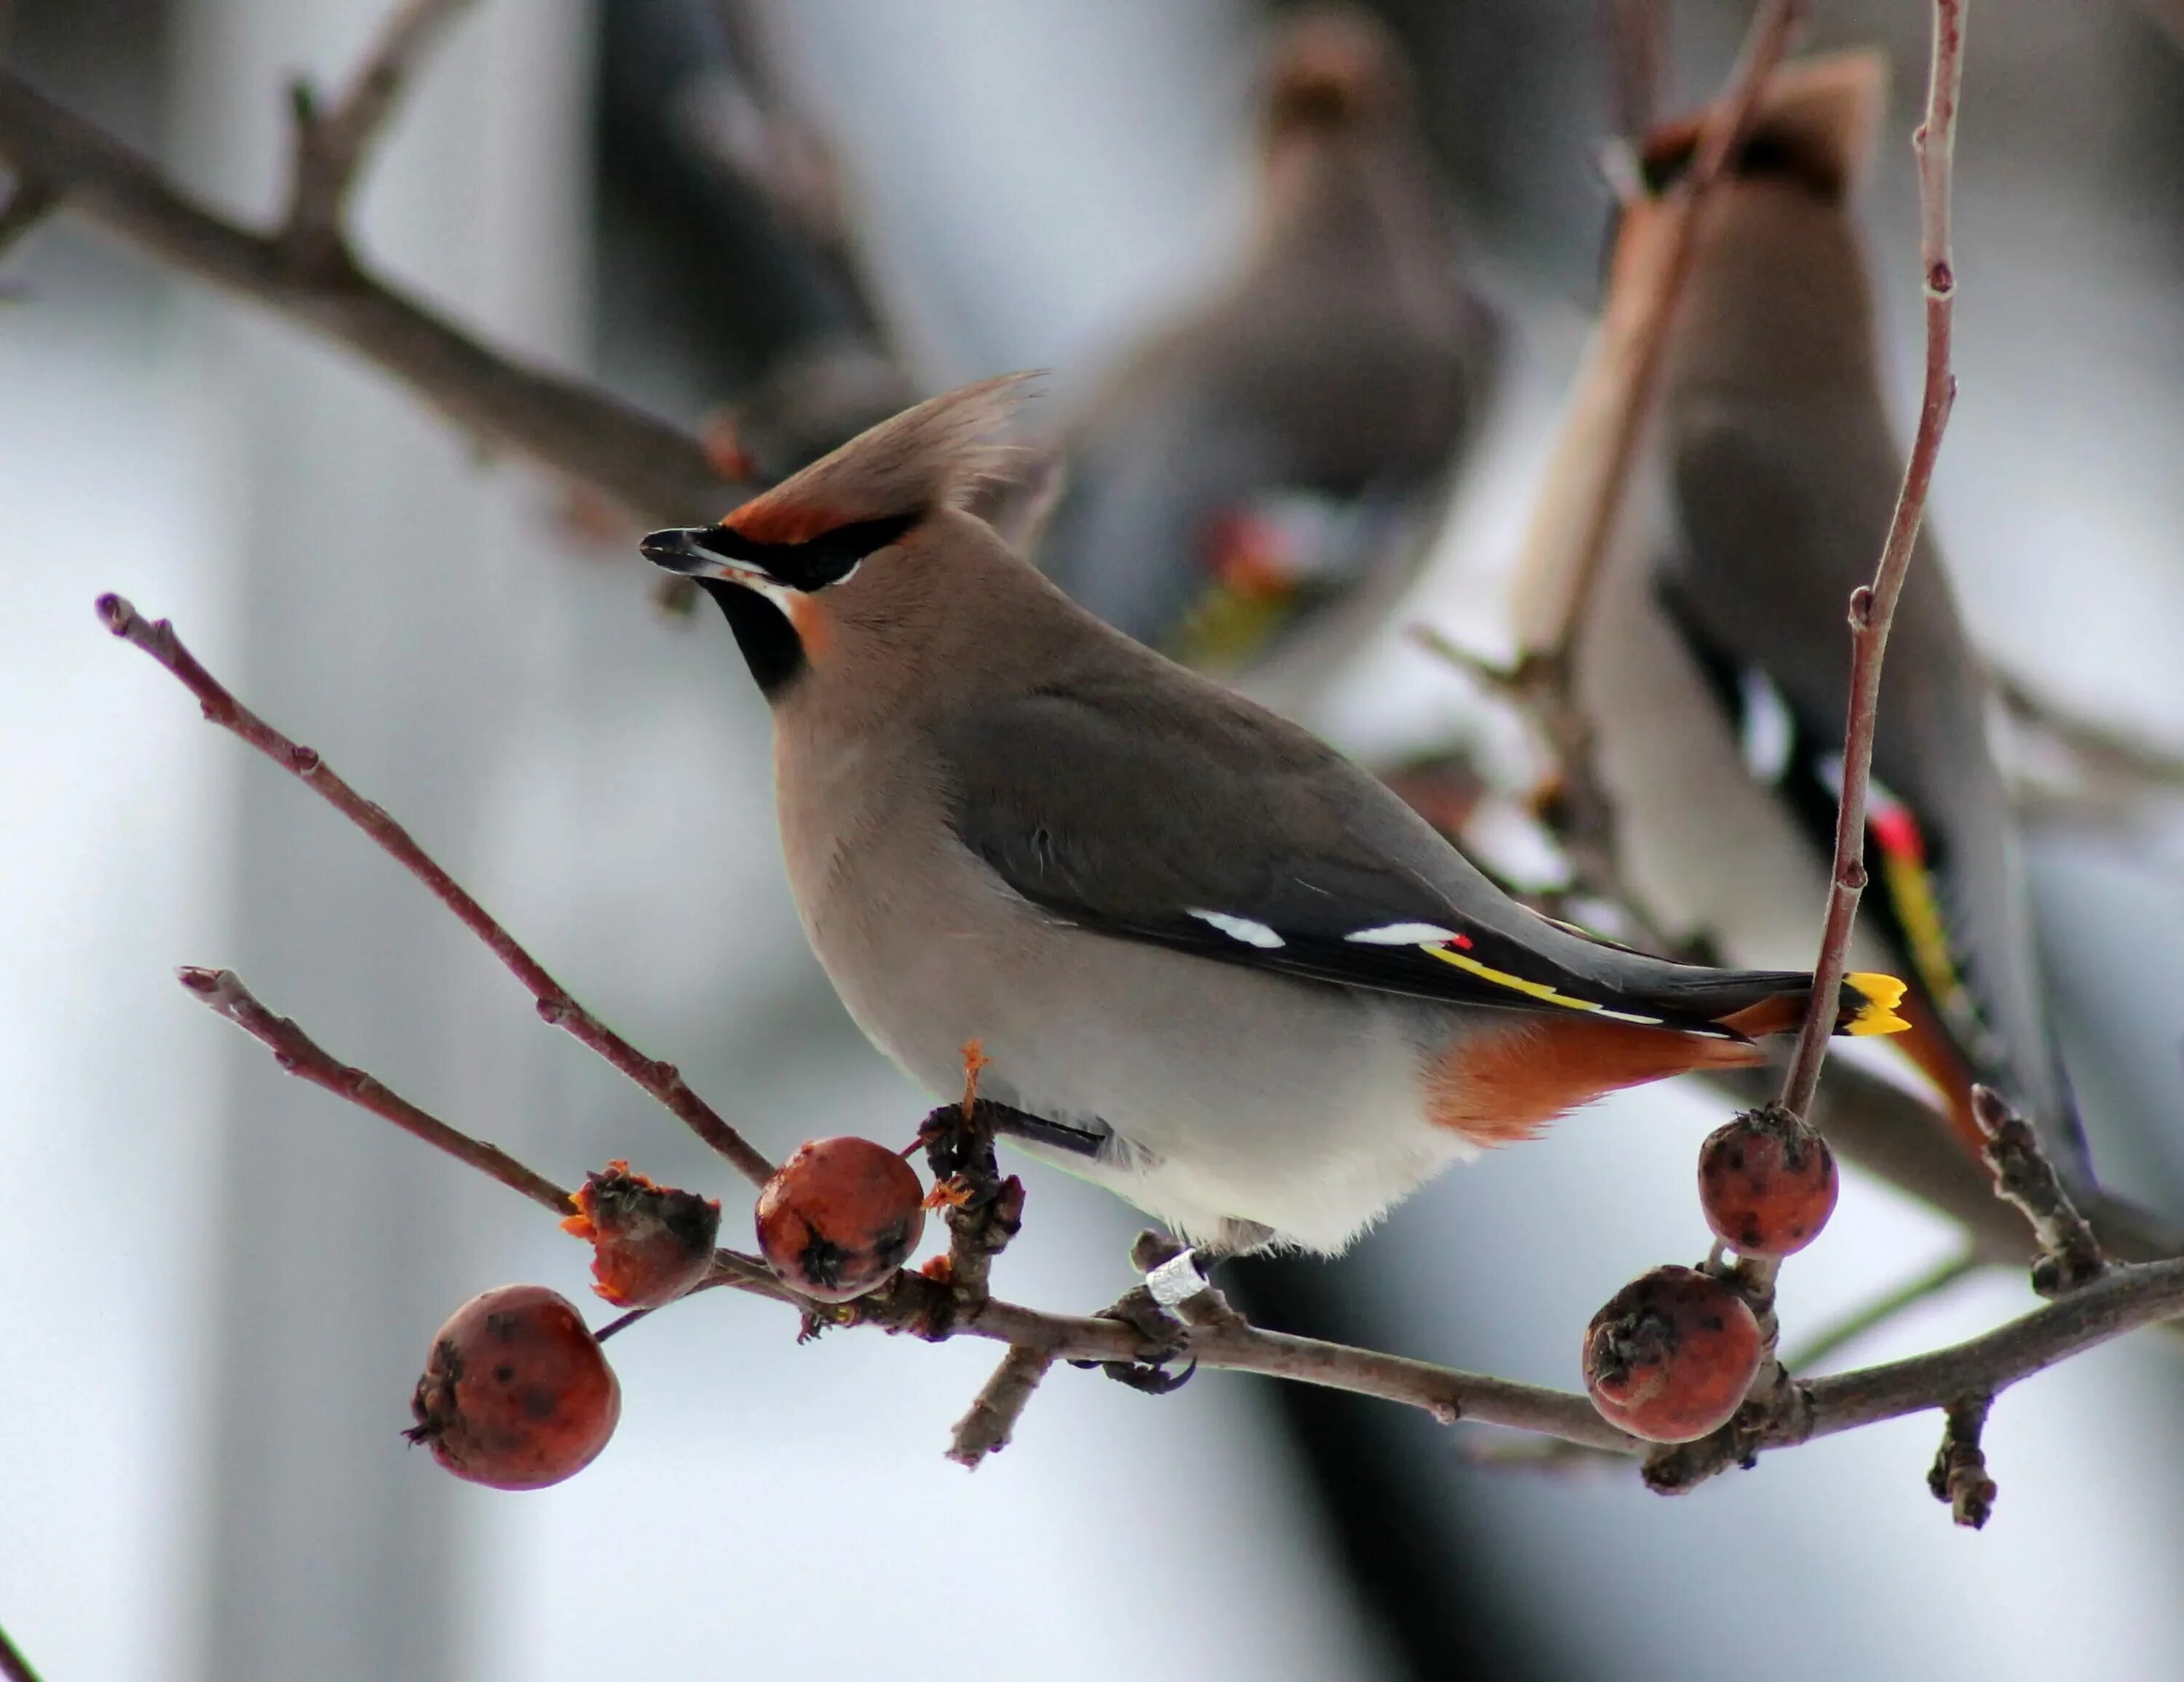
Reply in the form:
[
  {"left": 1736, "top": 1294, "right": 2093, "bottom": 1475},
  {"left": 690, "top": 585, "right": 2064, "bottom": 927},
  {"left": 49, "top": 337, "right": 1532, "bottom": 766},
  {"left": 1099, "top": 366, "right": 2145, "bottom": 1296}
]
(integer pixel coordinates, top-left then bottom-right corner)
[{"left": 0, "top": 70, "right": 740, "bottom": 520}]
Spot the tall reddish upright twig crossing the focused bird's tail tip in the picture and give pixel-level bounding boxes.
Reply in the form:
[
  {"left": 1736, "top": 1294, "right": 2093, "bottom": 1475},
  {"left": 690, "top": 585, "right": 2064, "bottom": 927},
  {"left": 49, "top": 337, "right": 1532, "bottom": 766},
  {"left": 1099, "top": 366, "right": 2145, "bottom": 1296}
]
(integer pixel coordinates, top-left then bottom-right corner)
[{"left": 1782, "top": 0, "right": 1968, "bottom": 1116}]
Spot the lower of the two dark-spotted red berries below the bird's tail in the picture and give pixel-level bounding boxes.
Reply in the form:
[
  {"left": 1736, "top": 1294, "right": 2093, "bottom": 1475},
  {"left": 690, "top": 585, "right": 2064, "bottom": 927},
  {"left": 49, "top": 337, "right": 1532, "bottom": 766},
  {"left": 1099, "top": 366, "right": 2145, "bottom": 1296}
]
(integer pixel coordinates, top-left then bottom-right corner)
[{"left": 1586, "top": 1267, "right": 1760, "bottom": 1442}]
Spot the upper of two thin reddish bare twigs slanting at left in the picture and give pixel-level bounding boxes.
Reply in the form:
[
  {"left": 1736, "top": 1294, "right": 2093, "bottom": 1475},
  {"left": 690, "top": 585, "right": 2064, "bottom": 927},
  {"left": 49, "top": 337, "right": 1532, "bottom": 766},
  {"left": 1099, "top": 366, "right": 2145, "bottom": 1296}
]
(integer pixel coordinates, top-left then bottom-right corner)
[{"left": 98, "top": 594, "right": 773, "bottom": 1186}]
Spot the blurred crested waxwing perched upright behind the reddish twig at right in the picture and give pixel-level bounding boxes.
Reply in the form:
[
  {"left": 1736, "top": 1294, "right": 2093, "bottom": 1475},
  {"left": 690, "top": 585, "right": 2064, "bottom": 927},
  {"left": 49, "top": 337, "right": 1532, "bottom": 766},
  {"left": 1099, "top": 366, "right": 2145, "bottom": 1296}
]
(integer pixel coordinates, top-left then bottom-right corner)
[{"left": 1516, "top": 52, "right": 2092, "bottom": 1189}]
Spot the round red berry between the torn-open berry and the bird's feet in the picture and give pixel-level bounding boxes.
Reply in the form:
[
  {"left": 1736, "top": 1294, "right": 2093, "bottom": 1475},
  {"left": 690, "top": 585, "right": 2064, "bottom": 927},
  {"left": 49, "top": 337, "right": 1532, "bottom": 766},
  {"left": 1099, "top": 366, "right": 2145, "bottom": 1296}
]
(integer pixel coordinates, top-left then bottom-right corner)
[{"left": 758, "top": 1138, "right": 926, "bottom": 1302}]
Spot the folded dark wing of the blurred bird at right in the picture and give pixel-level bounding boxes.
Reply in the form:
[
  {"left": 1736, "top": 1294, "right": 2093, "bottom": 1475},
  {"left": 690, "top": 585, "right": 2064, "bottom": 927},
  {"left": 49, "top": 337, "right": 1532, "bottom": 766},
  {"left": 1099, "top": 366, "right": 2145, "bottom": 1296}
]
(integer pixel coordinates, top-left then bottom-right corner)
[{"left": 1662, "top": 397, "right": 2084, "bottom": 1162}]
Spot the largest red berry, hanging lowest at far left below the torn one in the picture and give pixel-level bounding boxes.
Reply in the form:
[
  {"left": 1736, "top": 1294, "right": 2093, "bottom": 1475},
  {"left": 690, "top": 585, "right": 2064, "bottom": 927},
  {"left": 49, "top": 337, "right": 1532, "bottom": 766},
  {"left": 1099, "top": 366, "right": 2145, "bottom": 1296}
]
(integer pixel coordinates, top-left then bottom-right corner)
[{"left": 404, "top": 1285, "right": 622, "bottom": 1490}]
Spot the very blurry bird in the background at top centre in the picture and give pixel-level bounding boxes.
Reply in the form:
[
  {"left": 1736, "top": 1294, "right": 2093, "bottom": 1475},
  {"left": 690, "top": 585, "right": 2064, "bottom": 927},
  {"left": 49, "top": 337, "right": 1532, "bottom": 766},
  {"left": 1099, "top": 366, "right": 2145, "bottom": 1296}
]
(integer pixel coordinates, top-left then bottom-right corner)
[{"left": 1037, "top": 9, "right": 1494, "bottom": 668}]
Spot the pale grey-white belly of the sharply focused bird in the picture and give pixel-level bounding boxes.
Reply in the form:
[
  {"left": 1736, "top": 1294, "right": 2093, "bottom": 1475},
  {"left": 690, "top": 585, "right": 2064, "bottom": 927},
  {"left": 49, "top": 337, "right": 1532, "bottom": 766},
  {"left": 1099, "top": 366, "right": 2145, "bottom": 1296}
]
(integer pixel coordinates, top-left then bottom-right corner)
[{"left": 808, "top": 825, "right": 1476, "bottom": 1252}]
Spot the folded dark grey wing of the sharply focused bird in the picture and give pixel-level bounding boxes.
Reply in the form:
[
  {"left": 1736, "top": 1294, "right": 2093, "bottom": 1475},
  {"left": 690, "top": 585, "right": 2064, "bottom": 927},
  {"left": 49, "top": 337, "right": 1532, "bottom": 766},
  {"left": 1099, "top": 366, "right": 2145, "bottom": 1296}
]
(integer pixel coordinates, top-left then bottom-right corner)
[{"left": 941, "top": 673, "right": 1806, "bottom": 1038}]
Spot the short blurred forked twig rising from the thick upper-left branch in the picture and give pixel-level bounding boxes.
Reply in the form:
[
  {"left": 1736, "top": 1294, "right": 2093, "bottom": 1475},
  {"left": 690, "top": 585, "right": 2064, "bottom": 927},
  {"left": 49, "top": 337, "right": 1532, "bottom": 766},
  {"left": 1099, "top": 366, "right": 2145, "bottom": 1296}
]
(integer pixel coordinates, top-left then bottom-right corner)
[{"left": 282, "top": 0, "right": 470, "bottom": 273}]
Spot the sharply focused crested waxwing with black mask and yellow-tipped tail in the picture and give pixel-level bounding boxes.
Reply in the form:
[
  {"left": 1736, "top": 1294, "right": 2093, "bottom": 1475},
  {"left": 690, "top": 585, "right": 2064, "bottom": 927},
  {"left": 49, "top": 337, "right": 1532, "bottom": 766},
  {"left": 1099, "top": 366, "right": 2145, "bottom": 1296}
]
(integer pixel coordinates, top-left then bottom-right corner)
[{"left": 644, "top": 378, "right": 1902, "bottom": 1252}]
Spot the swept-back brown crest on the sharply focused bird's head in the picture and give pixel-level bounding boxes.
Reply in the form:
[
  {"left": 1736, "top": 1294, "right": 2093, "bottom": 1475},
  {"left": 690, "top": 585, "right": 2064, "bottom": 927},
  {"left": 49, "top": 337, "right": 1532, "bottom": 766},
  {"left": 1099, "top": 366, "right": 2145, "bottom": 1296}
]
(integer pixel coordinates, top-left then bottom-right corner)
[{"left": 721, "top": 373, "right": 1037, "bottom": 544}]
